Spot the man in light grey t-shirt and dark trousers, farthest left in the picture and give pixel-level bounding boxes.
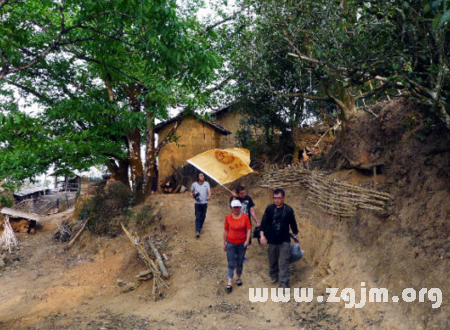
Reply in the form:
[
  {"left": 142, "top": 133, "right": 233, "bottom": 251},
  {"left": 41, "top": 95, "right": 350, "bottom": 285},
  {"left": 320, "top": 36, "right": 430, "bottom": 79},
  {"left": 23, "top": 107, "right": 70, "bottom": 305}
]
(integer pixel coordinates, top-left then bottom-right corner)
[{"left": 190, "top": 172, "right": 211, "bottom": 238}]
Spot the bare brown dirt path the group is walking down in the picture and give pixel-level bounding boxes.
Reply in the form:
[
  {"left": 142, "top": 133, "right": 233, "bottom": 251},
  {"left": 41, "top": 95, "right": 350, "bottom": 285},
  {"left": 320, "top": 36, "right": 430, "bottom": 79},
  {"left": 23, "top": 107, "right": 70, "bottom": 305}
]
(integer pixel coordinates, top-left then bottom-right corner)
[{"left": 0, "top": 194, "right": 411, "bottom": 330}]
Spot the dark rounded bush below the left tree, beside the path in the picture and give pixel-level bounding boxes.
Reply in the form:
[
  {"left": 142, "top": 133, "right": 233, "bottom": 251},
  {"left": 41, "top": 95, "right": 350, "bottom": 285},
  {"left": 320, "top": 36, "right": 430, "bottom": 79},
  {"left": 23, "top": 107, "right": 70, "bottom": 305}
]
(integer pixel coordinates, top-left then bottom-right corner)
[{"left": 79, "top": 182, "right": 133, "bottom": 236}]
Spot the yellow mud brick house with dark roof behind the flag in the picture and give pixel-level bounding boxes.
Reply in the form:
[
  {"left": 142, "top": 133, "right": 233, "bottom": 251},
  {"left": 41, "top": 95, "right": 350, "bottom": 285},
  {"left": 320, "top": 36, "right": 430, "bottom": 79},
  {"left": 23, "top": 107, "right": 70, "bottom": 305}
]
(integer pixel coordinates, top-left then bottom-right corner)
[{"left": 155, "top": 107, "right": 241, "bottom": 187}]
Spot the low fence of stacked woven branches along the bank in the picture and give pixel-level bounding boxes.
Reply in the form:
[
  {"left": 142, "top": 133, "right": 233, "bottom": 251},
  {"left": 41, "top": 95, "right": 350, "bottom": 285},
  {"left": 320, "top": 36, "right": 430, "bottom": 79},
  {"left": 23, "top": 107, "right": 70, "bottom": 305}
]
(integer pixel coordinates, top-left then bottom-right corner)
[{"left": 260, "top": 165, "right": 391, "bottom": 217}]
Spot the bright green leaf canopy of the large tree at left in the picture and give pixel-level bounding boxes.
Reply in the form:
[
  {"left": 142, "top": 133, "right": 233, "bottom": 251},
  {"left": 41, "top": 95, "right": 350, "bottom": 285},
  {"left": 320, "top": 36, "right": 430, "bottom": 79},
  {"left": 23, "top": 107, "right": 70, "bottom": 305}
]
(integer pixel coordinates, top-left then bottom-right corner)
[{"left": 0, "top": 0, "right": 222, "bottom": 188}]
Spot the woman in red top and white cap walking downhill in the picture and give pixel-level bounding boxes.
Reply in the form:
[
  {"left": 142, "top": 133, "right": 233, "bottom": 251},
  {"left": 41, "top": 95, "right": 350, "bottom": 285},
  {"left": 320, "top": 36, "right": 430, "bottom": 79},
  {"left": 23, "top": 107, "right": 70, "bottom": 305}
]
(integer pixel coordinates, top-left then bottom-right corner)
[{"left": 223, "top": 200, "right": 252, "bottom": 293}]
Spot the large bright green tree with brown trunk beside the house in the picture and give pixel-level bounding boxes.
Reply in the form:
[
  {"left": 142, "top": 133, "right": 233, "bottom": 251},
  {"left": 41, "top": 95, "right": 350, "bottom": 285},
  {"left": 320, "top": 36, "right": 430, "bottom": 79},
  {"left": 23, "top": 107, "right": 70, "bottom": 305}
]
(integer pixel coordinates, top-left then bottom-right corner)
[{"left": 0, "top": 1, "right": 220, "bottom": 199}]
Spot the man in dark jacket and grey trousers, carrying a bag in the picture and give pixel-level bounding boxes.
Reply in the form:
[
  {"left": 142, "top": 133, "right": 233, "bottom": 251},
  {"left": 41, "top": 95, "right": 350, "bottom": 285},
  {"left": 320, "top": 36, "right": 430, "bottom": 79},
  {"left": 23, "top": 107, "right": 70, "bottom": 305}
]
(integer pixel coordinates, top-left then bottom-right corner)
[{"left": 259, "top": 189, "right": 298, "bottom": 288}]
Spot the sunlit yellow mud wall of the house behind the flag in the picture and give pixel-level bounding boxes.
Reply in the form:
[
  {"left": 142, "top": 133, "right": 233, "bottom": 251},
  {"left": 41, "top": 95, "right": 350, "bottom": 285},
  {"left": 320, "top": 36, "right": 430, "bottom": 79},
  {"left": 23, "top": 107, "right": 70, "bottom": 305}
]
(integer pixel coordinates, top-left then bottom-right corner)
[{"left": 158, "top": 118, "right": 222, "bottom": 183}]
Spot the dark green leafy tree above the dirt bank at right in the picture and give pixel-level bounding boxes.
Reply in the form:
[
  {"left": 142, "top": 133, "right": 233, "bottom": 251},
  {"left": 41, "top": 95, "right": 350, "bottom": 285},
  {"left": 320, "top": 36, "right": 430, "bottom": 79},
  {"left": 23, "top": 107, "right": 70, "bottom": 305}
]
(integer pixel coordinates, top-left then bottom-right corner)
[{"left": 232, "top": 0, "right": 450, "bottom": 128}]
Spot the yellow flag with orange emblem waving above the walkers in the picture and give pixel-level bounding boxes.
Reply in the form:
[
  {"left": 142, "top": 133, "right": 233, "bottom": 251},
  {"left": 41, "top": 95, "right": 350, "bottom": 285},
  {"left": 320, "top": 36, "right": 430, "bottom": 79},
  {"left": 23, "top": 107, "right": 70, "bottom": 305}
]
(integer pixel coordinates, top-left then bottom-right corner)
[{"left": 187, "top": 148, "right": 253, "bottom": 185}]
